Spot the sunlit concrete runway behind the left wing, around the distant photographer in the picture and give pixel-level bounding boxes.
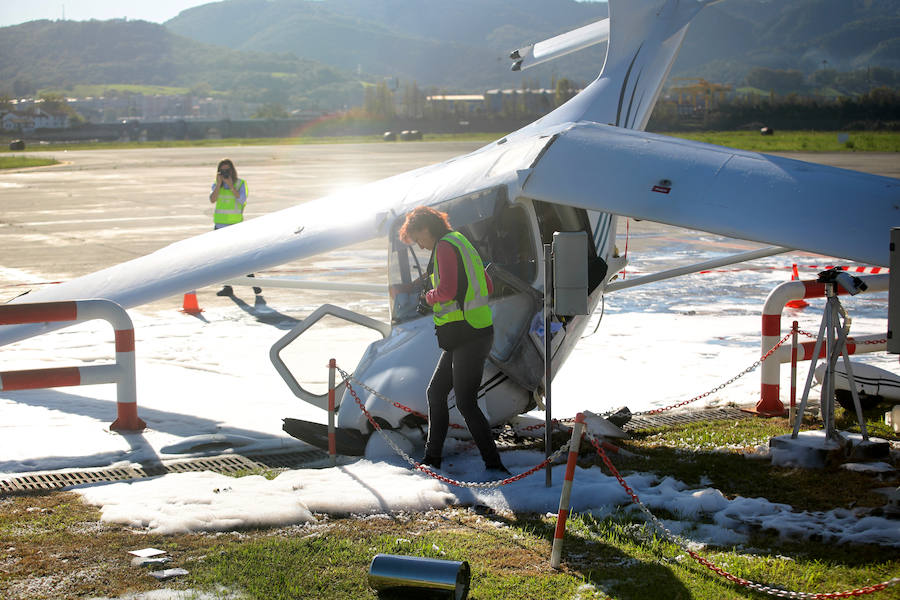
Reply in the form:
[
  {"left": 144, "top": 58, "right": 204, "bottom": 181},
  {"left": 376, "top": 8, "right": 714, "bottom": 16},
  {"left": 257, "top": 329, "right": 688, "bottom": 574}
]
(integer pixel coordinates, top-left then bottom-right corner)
[{"left": 0, "top": 142, "right": 900, "bottom": 309}]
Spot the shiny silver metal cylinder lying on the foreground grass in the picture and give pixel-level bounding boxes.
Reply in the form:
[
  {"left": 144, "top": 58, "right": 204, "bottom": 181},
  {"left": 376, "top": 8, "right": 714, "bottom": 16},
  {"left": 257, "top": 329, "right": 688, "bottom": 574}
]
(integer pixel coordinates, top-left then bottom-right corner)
[{"left": 369, "top": 554, "right": 469, "bottom": 600}]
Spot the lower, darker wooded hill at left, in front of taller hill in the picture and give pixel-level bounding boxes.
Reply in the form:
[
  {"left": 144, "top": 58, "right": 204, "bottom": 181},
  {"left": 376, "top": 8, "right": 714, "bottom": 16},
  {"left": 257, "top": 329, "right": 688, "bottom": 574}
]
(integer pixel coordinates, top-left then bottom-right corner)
[{"left": 0, "top": 20, "right": 361, "bottom": 107}]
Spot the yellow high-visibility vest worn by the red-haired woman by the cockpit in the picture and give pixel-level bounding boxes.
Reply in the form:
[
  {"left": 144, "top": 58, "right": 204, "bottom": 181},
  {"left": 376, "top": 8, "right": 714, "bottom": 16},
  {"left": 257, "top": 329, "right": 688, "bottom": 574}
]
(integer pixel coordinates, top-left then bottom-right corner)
[{"left": 431, "top": 231, "right": 493, "bottom": 329}]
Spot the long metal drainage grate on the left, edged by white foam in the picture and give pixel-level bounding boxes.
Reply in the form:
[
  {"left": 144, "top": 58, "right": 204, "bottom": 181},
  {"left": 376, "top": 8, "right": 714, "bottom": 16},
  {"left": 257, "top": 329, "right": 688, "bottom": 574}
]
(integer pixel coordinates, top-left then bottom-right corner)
[{"left": 0, "top": 449, "right": 328, "bottom": 495}]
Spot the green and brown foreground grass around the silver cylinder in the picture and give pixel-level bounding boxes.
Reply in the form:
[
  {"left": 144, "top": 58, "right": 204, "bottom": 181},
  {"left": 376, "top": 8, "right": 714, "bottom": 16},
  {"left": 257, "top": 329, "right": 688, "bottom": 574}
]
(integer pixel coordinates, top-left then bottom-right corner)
[{"left": 0, "top": 409, "right": 900, "bottom": 600}]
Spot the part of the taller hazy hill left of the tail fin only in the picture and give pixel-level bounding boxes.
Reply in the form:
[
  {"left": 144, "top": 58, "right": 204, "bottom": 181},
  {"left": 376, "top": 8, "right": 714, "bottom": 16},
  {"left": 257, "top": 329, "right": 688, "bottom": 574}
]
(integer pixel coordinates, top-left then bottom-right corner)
[{"left": 166, "top": 0, "right": 607, "bottom": 90}]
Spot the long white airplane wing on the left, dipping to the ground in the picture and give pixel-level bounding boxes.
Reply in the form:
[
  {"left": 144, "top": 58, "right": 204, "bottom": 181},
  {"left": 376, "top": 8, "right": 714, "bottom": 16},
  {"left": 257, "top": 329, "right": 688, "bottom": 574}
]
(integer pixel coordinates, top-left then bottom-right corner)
[{"left": 0, "top": 135, "right": 551, "bottom": 345}]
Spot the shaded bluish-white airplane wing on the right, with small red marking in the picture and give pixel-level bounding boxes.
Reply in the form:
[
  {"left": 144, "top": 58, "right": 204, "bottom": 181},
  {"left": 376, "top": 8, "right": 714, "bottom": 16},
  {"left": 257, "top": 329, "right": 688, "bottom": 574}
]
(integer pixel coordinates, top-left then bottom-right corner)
[{"left": 523, "top": 123, "right": 900, "bottom": 266}]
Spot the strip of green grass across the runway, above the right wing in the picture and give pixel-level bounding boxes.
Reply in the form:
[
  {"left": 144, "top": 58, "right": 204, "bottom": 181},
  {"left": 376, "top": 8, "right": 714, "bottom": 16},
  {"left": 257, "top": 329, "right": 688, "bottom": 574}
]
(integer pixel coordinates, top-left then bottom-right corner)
[{"left": 666, "top": 131, "right": 900, "bottom": 152}]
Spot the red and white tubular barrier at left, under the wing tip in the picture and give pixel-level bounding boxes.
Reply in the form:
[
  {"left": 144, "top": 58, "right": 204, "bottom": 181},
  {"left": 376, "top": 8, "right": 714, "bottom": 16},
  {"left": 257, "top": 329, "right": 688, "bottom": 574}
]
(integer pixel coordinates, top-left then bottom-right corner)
[{"left": 0, "top": 300, "right": 147, "bottom": 431}]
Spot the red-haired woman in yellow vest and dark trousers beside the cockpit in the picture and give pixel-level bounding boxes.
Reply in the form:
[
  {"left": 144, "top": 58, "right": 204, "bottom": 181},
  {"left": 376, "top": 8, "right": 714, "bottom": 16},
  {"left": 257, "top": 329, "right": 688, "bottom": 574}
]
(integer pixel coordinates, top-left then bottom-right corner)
[{"left": 400, "top": 206, "right": 509, "bottom": 475}]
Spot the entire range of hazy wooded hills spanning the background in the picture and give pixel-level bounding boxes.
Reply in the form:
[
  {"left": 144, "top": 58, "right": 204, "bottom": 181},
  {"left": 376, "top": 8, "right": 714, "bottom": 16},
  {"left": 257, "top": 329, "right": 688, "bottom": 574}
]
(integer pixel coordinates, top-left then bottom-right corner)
[{"left": 0, "top": 0, "right": 900, "bottom": 116}]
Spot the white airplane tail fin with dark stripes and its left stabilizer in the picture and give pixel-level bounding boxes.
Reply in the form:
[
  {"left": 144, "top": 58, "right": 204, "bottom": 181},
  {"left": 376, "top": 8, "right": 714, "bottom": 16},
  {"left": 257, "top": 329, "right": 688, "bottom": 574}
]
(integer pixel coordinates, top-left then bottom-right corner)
[{"left": 514, "top": 0, "right": 719, "bottom": 130}]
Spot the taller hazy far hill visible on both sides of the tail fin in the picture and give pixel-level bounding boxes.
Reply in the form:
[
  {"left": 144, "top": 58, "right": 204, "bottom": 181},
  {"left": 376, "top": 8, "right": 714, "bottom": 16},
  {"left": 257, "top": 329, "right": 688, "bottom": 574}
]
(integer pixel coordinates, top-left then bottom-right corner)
[{"left": 166, "top": 0, "right": 900, "bottom": 90}]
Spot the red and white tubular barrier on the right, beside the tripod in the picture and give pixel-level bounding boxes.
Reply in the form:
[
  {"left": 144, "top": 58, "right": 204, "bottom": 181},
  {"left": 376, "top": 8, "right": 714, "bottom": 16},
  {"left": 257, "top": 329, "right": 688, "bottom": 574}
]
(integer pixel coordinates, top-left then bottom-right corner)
[{"left": 756, "top": 274, "right": 890, "bottom": 416}]
